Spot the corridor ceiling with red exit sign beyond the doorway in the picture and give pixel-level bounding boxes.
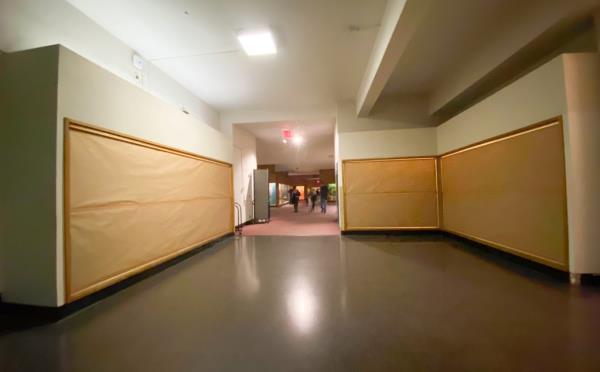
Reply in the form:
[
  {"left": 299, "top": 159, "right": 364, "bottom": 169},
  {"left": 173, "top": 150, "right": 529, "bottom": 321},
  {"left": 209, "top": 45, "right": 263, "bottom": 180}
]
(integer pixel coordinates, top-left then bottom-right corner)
[{"left": 238, "top": 120, "right": 335, "bottom": 172}]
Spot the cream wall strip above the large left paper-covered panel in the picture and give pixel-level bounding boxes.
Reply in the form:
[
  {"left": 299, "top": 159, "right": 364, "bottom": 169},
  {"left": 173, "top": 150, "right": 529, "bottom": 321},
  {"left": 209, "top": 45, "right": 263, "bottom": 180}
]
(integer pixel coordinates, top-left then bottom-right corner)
[{"left": 58, "top": 47, "right": 232, "bottom": 163}]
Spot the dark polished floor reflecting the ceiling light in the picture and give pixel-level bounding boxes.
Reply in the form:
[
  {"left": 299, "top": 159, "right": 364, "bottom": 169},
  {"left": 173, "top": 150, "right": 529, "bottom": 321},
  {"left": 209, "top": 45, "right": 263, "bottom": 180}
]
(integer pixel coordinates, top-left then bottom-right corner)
[{"left": 0, "top": 236, "right": 600, "bottom": 372}]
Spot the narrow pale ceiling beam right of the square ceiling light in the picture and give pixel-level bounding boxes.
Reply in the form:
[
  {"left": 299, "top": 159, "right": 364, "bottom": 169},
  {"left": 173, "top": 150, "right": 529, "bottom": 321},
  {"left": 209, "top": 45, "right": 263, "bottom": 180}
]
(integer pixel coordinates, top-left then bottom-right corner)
[{"left": 356, "top": 0, "right": 431, "bottom": 117}]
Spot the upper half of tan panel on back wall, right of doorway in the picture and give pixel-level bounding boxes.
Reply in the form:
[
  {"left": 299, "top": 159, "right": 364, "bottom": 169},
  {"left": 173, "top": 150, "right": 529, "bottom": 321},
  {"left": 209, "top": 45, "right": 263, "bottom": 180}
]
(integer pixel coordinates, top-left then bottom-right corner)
[{"left": 344, "top": 158, "right": 436, "bottom": 194}]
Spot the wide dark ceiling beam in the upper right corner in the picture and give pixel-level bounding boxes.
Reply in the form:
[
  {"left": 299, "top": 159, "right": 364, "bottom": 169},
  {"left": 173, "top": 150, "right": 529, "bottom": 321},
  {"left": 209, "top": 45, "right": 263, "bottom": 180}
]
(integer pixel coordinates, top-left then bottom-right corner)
[{"left": 429, "top": 0, "right": 600, "bottom": 116}]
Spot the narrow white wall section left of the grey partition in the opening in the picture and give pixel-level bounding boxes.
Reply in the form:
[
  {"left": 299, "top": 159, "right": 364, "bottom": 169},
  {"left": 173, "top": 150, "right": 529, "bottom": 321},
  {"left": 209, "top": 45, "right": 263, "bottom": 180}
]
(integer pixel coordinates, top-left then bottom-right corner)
[{"left": 233, "top": 127, "right": 257, "bottom": 224}]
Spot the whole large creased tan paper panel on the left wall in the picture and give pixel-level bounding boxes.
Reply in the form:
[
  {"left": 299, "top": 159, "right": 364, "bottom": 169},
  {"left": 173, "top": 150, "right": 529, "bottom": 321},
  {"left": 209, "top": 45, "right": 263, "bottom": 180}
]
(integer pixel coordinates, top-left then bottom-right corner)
[{"left": 66, "top": 125, "right": 233, "bottom": 300}]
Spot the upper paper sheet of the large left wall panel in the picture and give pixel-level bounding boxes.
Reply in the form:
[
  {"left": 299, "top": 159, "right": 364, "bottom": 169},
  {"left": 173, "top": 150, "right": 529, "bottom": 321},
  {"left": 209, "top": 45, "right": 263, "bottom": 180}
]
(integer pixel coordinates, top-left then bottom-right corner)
[{"left": 70, "top": 130, "right": 231, "bottom": 208}]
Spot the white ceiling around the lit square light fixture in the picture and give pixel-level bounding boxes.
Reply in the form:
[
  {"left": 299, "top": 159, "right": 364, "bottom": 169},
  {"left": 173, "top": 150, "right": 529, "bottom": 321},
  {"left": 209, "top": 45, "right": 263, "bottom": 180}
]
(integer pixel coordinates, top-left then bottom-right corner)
[{"left": 69, "top": 0, "right": 385, "bottom": 110}]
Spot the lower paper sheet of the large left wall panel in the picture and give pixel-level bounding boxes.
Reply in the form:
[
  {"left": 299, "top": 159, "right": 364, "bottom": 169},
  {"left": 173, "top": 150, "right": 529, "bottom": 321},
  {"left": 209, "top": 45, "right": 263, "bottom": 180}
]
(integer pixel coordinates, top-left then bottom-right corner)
[{"left": 71, "top": 199, "right": 231, "bottom": 293}]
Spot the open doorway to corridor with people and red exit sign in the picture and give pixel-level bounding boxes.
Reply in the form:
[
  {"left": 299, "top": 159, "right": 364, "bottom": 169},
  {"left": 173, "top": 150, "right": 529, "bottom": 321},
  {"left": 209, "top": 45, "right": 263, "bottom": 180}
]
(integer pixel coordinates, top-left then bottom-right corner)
[{"left": 237, "top": 120, "right": 340, "bottom": 236}]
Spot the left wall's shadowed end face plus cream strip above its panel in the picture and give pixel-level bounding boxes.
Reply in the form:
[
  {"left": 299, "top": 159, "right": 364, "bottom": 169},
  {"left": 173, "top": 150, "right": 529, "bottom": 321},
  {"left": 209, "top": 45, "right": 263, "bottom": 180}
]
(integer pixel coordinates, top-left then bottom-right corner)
[{"left": 0, "top": 46, "right": 233, "bottom": 306}]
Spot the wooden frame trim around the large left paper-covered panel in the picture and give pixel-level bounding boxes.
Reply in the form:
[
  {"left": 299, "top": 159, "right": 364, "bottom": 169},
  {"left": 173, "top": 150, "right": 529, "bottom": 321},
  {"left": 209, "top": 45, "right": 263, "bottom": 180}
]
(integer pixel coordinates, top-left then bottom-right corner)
[{"left": 63, "top": 118, "right": 235, "bottom": 303}]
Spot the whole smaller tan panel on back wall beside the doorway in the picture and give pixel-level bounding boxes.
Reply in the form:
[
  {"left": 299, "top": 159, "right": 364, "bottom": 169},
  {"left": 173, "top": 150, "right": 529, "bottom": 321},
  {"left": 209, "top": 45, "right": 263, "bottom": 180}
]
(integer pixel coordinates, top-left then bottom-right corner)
[{"left": 343, "top": 158, "right": 438, "bottom": 231}]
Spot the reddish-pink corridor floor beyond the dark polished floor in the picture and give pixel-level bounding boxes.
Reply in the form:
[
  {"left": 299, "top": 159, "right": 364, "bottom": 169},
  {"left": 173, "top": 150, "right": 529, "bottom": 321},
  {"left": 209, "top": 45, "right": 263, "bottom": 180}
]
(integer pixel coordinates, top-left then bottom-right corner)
[{"left": 242, "top": 201, "right": 340, "bottom": 236}]
